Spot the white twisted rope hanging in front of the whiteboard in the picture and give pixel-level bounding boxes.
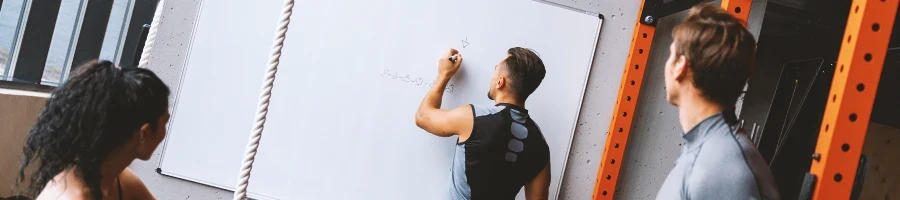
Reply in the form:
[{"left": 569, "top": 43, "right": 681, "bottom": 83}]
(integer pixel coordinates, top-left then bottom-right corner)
[{"left": 234, "top": 0, "right": 294, "bottom": 200}]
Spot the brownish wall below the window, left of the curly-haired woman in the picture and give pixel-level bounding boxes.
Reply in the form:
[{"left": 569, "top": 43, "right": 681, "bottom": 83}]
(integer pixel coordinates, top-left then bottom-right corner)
[{"left": 0, "top": 89, "right": 47, "bottom": 197}]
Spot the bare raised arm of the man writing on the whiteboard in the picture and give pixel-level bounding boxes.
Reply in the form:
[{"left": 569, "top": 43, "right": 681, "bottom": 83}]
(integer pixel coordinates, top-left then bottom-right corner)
[{"left": 416, "top": 49, "right": 474, "bottom": 140}]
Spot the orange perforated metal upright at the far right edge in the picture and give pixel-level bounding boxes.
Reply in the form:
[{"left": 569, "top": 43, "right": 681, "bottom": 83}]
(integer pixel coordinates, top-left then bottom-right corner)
[{"left": 804, "top": 0, "right": 900, "bottom": 199}]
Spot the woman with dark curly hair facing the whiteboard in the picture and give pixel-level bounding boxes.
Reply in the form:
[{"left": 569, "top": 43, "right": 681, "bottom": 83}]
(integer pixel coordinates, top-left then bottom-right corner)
[{"left": 17, "top": 61, "right": 169, "bottom": 200}]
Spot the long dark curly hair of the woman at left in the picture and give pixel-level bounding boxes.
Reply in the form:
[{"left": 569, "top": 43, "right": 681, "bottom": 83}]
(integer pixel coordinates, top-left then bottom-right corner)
[{"left": 16, "top": 61, "right": 169, "bottom": 199}]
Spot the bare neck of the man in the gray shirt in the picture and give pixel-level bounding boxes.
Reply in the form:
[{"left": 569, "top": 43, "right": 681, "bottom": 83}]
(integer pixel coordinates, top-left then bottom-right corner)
[{"left": 678, "top": 95, "right": 724, "bottom": 133}]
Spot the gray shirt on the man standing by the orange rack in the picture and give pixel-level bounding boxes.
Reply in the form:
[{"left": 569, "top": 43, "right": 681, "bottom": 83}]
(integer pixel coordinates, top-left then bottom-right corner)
[{"left": 656, "top": 113, "right": 780, "bottom": 199}]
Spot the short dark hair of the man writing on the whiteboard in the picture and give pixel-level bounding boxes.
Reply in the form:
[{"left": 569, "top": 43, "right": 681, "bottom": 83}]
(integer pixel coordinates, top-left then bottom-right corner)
[{"left": 503, "top": 47, "right": 547, "bottom": 101}]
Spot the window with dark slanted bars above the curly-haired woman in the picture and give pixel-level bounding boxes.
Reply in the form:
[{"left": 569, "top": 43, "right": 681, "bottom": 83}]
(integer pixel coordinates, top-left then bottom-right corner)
[{"left": 0, "top": 0, "right": 158, "bottom": 87}]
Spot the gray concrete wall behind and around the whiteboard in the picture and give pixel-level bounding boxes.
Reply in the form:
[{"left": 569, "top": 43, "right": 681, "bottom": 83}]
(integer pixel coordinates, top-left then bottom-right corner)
[{"left": 131, "top": 0, "right": 765, "bottom": 199}]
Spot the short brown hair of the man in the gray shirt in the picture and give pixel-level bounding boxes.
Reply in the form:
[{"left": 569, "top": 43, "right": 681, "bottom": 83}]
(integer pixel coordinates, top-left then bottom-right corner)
[{"left": 672, "top": 4, "right": 756, "bottom": 107}]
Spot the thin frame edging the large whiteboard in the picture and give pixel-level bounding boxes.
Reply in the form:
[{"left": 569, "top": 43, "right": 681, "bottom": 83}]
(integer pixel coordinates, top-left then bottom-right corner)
[{"left": 156, "top": 0, "right": 605, "bottom": 199}]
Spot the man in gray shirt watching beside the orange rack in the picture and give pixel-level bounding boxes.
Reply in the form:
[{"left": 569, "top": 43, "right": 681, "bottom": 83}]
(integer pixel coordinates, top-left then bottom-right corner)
[{"left": 656, "top": 4, "right": 779, "bottom": 200}]
